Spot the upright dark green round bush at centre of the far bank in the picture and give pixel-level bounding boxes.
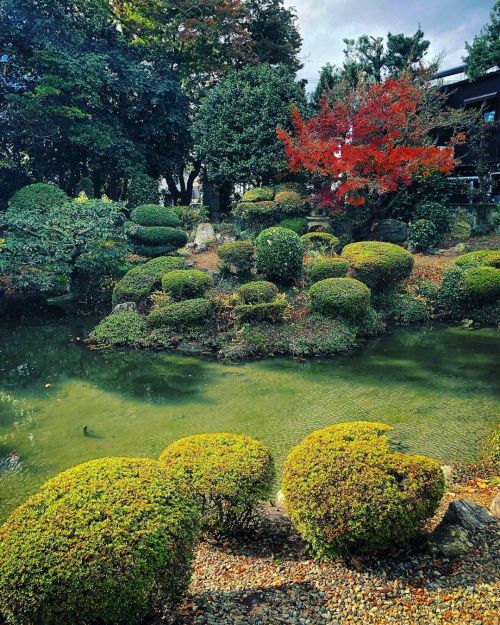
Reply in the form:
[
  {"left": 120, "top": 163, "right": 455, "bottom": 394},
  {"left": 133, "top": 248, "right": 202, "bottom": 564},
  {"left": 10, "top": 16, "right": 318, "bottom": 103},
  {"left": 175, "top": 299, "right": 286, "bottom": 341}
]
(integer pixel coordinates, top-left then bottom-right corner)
[{"left": 255, "top": 227, "right": 304, "bottom": 283}]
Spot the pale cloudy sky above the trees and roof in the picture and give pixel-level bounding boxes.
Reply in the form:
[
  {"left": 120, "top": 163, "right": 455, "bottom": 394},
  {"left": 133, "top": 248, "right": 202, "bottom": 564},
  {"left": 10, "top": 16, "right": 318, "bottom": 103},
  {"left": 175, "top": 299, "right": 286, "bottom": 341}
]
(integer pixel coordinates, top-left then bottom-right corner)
[{"left": 285, "top": 0, "right": 494, "bottom": 88}]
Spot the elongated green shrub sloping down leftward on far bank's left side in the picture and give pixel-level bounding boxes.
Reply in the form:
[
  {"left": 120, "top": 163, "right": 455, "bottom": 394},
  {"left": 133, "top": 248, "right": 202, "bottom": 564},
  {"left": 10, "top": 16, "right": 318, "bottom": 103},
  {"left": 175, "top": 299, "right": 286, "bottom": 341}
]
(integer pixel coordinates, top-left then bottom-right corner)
[{"left": 113, "top": 256, "right": 186, "bottom": 306}]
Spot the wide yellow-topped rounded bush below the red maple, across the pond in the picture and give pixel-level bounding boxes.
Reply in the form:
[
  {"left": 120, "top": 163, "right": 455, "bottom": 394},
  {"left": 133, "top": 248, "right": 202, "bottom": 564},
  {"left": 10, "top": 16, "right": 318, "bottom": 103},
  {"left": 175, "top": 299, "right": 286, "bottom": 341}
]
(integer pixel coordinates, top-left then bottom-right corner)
[{"left": 342, "top": 241, "right": 414, "bottom": 290}]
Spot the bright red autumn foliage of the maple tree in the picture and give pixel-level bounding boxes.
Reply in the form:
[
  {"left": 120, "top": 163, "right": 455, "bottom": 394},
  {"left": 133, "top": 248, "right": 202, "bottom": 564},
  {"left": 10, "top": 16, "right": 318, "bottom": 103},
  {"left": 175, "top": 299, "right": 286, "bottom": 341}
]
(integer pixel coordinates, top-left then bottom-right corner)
[{"left": 278, "top": 76, "right": 463, "bottom": 212}]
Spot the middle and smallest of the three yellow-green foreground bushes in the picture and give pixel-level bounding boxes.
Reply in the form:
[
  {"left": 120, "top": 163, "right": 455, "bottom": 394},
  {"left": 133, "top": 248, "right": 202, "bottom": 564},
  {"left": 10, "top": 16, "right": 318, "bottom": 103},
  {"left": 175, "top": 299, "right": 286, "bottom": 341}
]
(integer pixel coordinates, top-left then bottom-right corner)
[{"left": 160, "top": 433, "right": 274, "bottom": 533}]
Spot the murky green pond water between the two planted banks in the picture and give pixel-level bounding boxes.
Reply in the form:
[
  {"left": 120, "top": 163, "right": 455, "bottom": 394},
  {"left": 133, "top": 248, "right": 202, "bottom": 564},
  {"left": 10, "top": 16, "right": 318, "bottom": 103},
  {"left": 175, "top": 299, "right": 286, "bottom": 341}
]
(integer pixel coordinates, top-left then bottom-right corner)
[{"left": 0, "top": 321, "right": 500, "bottom": 518}]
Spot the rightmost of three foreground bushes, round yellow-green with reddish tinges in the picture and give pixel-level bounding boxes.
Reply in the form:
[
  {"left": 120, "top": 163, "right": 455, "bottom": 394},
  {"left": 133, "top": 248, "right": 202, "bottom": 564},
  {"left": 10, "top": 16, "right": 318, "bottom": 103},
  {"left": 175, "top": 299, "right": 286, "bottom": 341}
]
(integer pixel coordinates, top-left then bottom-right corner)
[{"left": 282, "top": 422, "right": 444, "bottom": 557}]
